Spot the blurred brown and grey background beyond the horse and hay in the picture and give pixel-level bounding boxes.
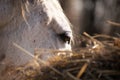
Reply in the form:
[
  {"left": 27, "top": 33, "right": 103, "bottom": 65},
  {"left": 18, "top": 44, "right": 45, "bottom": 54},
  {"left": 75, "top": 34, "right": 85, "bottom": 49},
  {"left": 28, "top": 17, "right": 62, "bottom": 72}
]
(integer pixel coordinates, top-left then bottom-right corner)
[{"left": 59, "top": 0, "right": 120, "bottom": 35}]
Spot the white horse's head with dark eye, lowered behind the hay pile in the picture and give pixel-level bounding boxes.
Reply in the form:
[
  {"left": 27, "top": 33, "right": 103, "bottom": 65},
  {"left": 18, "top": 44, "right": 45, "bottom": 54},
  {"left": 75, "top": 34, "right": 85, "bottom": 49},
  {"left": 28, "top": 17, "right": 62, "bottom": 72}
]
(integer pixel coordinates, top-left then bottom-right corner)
[{"left": 0, "top": 0, "right": 72, "bottom": 77}]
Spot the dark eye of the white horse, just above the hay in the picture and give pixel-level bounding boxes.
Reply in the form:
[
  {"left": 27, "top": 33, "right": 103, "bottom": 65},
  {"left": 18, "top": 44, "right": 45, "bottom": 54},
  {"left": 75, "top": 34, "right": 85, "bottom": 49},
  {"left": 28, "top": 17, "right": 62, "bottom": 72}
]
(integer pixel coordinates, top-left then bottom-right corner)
[{"left": 58, "top": 31, "right": 72, "bottom": 44}]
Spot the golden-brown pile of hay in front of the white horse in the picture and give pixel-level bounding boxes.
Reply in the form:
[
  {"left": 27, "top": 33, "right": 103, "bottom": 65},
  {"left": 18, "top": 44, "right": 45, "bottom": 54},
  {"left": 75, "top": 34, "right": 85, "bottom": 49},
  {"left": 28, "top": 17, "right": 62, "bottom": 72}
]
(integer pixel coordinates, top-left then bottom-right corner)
[{"left": 4, "top": 33, "right": 120, "bottom": 80}]
